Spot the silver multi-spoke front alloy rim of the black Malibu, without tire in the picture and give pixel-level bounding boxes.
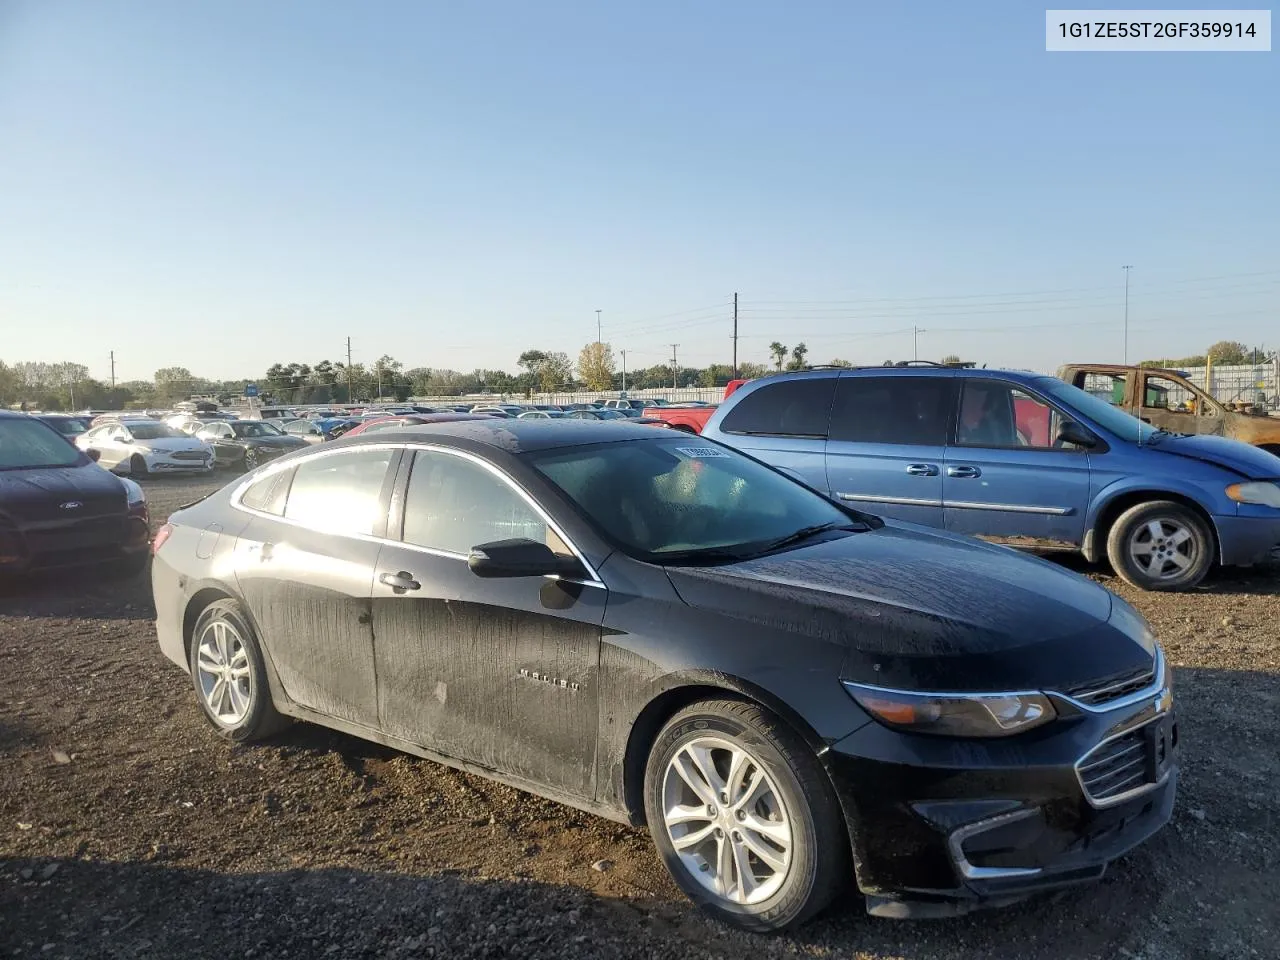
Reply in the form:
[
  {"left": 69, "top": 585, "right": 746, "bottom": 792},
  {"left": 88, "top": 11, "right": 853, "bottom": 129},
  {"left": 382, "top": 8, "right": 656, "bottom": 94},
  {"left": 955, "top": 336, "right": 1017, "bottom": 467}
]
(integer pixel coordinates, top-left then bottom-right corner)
[{"left": 662, "top": 737, "right": 794, "bottom": 904}]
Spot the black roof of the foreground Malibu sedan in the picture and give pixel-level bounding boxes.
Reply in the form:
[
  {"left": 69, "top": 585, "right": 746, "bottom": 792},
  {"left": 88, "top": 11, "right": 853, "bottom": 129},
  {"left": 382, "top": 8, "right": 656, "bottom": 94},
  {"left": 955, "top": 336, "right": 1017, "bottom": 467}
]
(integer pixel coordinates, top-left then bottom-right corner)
[{"left": 325, "top": 417, "right": 667, "bottom": 453}]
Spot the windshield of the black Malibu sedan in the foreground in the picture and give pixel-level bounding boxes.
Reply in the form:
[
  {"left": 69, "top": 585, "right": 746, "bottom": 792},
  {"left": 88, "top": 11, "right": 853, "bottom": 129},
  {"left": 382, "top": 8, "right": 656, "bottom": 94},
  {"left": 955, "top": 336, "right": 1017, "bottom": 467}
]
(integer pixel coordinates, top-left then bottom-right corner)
[{"left": 525, "top": 438, "right": 870, "bottom": 563}]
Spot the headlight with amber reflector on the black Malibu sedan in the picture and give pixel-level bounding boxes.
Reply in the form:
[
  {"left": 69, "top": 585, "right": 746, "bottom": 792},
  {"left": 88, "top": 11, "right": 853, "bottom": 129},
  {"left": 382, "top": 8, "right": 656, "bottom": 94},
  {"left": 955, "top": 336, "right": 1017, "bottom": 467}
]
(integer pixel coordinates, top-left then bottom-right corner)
[{"left": 845, "top": 681, "right": 1057, "bottom": 737}]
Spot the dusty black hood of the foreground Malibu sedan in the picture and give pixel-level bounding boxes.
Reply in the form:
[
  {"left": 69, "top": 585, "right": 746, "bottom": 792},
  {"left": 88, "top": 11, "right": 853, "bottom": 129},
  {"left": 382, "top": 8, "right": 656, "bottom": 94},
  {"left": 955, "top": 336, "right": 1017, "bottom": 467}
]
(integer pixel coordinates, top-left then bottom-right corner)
[{"left": 667, "top": 522, "right": 1155, "bottom": 691}]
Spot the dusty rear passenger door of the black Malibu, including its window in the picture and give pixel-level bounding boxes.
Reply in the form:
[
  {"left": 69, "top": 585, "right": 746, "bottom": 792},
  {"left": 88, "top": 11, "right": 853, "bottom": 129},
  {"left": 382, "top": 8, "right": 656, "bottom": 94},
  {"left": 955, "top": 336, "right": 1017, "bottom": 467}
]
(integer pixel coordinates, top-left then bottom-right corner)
[{"left": 234, "top": 448, "right": 398, "bottom": 730}]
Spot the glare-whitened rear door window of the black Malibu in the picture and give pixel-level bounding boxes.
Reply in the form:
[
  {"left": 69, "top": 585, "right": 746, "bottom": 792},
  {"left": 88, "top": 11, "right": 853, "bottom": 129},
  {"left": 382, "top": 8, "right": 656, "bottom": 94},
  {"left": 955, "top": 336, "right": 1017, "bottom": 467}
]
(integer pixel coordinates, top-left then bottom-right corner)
[{"left": 284, "top": 449, "right": 392, "bottom": 536}]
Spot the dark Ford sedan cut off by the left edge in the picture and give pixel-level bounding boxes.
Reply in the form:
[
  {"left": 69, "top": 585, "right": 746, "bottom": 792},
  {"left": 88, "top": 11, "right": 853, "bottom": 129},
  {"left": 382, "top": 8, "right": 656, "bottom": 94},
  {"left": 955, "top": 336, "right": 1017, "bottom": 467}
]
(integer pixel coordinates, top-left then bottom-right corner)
[{"left": 0, "top": 411, "right": 150, "bottom": 577}]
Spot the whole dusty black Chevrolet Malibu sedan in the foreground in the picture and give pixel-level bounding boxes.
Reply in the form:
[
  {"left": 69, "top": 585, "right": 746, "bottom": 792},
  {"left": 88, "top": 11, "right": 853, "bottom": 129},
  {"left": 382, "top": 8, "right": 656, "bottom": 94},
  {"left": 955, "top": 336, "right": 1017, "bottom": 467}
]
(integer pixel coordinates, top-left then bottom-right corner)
[{"left": 152, "top": 420, "right": 1176, "bottom": 931}]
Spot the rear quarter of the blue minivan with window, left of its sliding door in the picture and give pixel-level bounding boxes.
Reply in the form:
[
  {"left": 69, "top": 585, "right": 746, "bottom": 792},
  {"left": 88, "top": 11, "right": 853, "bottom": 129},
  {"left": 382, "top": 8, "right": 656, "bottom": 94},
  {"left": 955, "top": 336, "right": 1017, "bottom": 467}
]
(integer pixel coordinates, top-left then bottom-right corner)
[{"left": 717, "top": 374, "right": 836, "bottom": 490}]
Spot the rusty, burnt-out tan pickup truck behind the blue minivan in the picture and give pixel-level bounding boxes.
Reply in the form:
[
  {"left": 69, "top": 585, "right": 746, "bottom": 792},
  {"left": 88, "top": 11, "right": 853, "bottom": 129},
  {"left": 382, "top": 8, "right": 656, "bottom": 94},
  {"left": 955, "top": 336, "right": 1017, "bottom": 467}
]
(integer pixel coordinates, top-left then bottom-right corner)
[{"left": 1057, "top": 364, "right": 1280, "bottom": 456}]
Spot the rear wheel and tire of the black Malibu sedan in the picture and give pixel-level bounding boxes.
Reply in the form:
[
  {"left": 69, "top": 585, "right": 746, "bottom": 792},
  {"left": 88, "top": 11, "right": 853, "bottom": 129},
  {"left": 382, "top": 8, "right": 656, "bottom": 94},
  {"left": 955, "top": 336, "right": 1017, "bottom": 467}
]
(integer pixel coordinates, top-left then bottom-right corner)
[{"left": 188, "top": 600, "right": 288, "bottom": 742}]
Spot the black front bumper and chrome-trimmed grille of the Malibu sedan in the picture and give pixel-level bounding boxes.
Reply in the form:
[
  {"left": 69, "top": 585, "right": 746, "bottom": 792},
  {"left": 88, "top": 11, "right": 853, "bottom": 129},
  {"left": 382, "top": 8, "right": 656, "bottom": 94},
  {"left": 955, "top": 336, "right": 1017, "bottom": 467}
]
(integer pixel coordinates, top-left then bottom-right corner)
[{"left": 823, "top": 689, "right": 1178, "bottom": 916}]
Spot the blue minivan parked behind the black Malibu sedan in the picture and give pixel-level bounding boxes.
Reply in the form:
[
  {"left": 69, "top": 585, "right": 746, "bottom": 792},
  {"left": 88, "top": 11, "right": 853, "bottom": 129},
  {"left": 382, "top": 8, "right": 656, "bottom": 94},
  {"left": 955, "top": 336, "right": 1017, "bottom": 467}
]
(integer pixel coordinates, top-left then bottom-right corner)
[{"left": 703, "top": 366, "right": 1280, "bottom": 590}]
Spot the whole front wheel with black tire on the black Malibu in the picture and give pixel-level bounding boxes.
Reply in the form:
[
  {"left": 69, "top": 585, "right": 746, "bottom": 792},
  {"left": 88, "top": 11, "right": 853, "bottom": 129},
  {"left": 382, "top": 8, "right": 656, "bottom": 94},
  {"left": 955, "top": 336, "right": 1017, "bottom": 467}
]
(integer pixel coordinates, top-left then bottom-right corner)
[{"left": 644, "top": 700, "right": 849, "bottom": 932}]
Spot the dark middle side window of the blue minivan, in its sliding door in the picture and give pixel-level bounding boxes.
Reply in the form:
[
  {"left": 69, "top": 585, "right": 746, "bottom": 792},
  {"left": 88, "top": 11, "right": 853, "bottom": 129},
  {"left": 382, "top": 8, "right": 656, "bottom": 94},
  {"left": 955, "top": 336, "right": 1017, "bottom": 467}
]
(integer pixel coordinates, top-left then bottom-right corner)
[{"left": 831, "top": 376, "right": 955, "bottom": 447}]
